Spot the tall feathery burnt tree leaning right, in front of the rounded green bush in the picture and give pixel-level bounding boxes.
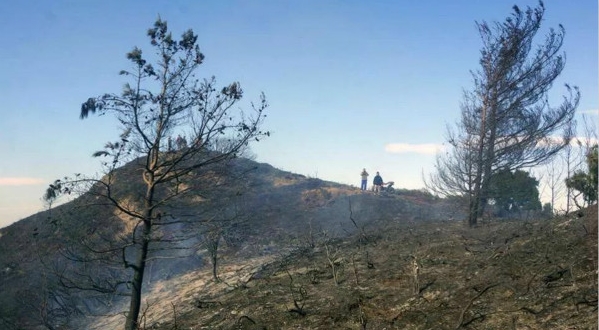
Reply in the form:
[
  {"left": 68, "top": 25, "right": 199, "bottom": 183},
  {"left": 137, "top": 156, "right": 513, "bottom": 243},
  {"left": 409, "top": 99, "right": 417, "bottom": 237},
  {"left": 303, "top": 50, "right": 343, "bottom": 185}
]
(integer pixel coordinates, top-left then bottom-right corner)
[{"left": 429, "top": 2, "right": 580, "bottom": 225}]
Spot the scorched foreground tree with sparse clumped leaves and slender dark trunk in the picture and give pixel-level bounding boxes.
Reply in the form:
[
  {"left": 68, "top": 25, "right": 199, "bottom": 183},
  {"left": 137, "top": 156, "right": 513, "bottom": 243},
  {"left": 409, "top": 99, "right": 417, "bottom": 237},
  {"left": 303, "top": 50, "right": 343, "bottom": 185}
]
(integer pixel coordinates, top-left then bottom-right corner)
[{"left": 46, "top": 19, "right": 269, "bottom": 330}]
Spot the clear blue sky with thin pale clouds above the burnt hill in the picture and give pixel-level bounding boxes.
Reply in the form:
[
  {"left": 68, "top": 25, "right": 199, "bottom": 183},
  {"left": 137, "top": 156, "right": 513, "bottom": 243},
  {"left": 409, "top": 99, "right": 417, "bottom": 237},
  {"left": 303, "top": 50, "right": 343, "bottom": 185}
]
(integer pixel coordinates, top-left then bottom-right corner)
[{"left": 0, "top": 0, "right": 599, "bottom": 227}]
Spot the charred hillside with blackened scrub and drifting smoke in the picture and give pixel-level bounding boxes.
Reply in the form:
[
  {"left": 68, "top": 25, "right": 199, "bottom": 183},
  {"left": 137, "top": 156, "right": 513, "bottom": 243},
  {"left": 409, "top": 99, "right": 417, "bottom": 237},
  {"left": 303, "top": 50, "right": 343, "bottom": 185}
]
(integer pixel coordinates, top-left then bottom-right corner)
[{"left": 0, "top": 158, "right": 597, "bottom": 330}]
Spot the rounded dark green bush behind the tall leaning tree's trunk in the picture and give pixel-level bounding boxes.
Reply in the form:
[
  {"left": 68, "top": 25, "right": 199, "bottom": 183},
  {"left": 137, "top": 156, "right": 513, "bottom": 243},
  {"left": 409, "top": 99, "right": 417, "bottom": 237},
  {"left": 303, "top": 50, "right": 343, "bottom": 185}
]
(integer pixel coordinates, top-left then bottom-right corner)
[{"left": 489, "top": 169, "right": 541, "bottom": 216}]
